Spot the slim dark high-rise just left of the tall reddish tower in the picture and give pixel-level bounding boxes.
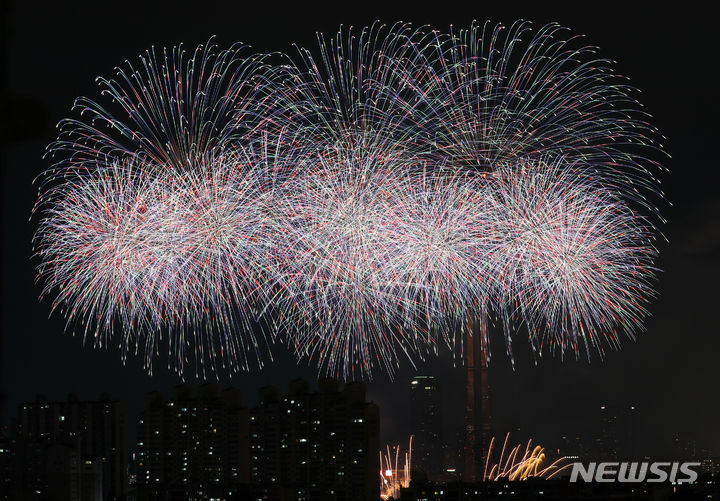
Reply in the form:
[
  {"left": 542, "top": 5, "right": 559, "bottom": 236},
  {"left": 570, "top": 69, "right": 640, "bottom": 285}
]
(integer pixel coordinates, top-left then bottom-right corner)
[{"left": 410, "top": 376, "right": 443, "bottom": 480}]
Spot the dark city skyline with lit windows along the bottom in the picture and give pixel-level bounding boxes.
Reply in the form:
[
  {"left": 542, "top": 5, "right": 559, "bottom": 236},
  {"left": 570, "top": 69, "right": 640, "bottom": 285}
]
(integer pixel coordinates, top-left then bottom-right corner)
[{"left": 0, "top": 376, "right": 720, "bottom": 500}]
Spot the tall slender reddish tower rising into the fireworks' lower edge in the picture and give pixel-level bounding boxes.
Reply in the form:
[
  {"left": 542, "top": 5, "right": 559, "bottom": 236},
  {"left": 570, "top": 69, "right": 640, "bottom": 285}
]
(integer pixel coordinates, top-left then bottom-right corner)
[{"left": 463, "top": 317, "right": 492, "bottom": 482}]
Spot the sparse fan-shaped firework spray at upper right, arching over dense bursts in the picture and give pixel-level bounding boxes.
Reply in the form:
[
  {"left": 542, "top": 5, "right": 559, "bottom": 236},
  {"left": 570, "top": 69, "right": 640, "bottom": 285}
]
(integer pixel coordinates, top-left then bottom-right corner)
[{"left": 396, "top": 21, "right": 662, "bottom": 208}]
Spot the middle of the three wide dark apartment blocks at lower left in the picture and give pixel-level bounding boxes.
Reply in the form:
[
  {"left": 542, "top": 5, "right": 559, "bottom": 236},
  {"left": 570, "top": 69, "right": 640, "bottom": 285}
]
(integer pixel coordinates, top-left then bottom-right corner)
[{"left": 134, "top": 384, "right": 249, "bottom": 500}]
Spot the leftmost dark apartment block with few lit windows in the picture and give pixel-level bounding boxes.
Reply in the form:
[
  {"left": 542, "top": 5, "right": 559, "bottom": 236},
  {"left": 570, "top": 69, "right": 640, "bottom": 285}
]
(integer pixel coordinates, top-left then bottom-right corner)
[{"left": 15, "top": 394, "right": 127, "bottom": 501}]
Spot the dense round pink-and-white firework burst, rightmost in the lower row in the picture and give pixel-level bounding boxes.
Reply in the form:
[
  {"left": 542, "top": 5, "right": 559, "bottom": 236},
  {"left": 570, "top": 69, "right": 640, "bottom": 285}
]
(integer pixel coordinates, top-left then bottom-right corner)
[{"left": 484, "top": 162, "right": 656, "bottom": 355}]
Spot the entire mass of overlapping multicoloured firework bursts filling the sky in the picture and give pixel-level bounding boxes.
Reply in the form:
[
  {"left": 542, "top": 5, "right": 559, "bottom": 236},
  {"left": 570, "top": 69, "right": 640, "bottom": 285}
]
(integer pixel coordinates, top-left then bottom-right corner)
[{"left": 35, "top": 22, "right": 662, "bottom": 378}]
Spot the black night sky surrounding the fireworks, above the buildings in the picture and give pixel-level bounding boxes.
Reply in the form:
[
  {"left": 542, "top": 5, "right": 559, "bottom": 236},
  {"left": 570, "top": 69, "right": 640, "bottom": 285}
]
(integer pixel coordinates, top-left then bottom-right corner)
[{"left": 0, "top": 1, "right": 720, "bottom": 454}]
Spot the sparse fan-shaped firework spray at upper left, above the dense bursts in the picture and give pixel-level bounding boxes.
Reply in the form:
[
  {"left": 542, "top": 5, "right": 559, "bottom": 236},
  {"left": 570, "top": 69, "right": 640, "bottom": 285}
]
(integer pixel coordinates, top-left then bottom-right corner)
[{"left": 46, "top": 39, "right": 273, "bottom": 177}]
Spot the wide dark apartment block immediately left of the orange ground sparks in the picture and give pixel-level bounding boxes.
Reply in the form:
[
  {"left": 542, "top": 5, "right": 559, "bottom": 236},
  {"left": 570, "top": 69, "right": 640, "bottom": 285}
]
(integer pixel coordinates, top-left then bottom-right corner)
[{"left": 250, "top": 379, "right": 380, "bottom": 501}]
